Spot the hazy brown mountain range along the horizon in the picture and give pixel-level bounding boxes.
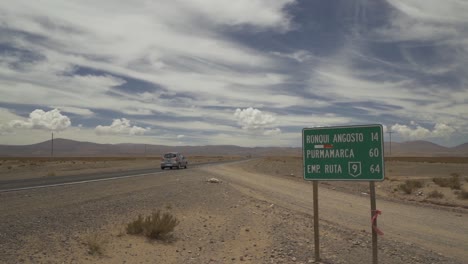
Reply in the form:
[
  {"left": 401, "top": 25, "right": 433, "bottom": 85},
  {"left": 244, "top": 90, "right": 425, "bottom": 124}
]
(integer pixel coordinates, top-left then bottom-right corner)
[{"left": 0, "top": 138, "right": 468, "bottom": 157}]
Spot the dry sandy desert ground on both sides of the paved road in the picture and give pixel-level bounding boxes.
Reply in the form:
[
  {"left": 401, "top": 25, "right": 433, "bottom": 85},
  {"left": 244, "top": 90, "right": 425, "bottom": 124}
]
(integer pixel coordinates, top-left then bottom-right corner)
[{"left": 0, "top": 156, "right": 468, "bottom": 263}]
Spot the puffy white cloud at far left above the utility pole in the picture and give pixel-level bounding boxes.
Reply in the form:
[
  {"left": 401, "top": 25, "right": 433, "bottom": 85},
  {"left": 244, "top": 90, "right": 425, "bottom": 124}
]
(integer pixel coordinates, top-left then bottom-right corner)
[{"left": 8, "top": 109, "right": 71, "bottom": 131}]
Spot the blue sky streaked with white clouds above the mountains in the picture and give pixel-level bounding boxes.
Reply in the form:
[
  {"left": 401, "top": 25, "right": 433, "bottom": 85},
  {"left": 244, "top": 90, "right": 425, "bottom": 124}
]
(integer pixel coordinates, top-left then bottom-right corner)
[{"left": 0, "top": 0, "right": 468, "bottom": 147}]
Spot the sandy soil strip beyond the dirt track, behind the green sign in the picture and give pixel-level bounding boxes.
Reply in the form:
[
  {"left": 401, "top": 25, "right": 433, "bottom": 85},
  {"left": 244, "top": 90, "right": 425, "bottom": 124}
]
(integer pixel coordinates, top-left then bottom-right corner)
[{"left": 242, "top": 157, "right": 468, "bottom": 209}]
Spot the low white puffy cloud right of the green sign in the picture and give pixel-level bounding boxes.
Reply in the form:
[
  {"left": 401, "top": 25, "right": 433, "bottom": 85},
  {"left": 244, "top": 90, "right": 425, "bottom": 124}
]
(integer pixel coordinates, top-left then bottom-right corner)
[{"left": 391, "top": 121, "right": 455, "bottom": 139}]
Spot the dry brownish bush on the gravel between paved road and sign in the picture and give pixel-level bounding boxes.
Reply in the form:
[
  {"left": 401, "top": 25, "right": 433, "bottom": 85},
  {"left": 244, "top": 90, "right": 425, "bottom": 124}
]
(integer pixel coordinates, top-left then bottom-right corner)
[{"left": 127, "top": 210, "right": 179, "bottom": 239}]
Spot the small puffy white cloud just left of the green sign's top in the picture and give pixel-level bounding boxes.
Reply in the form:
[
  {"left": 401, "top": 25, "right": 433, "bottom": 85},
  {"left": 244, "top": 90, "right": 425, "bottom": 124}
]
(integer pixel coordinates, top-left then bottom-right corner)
[{"left": 234, "top": 107, "right": 281, "bottom": 136}]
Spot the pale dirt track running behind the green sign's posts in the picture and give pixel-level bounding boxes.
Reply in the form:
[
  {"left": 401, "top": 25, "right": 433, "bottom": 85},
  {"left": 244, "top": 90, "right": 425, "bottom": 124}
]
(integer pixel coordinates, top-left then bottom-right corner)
[{"left": 202, "top": 165, "right": 468, "bottom": 263}]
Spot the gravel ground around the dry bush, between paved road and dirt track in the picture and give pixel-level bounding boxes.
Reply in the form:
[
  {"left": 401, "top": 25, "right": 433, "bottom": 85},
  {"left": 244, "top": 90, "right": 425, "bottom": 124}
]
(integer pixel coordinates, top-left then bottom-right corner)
[{"left": 0, "top": 164, "right": 459, "bottom": 264}]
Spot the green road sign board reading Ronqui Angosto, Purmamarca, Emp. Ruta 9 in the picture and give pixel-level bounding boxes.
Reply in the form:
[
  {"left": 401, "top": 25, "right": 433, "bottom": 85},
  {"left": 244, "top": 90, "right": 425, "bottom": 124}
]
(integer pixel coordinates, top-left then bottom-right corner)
[{"left": 302, "top": 125, "right": 385, "bottom": 181}]
